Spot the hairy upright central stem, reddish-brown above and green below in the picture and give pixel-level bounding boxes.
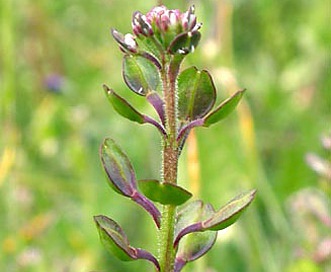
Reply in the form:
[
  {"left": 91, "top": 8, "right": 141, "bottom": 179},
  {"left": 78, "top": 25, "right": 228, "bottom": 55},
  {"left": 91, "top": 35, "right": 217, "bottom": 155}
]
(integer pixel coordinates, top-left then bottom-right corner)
[{"left": 159, "top": 57, "right": 180, "bottom": 272}]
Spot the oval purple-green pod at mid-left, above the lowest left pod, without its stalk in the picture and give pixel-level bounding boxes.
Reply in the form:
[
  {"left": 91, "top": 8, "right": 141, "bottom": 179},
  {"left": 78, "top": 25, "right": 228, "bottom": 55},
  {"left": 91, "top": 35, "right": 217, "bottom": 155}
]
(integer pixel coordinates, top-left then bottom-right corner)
[{"left": 100, "top": 138, "right": 136, "bottom": 197}]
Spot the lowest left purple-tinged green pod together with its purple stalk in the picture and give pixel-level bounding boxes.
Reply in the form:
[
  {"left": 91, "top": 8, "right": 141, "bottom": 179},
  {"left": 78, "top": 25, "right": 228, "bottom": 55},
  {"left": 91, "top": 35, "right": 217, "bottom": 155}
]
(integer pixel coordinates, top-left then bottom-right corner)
[{"left": 94, "top": 215, "right": 160, "bottom": 271}]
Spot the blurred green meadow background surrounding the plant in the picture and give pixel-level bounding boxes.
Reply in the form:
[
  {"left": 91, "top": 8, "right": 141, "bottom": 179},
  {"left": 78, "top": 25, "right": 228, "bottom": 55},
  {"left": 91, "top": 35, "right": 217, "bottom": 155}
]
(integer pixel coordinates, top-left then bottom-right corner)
[{"left": 0, "top": 0, "right": 331, "bottom": 272}]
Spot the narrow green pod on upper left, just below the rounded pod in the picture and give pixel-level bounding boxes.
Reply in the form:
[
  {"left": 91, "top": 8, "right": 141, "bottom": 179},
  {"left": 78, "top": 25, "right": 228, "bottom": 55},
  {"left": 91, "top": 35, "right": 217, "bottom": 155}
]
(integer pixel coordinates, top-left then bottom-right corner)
[{"left": 103, "top": 85, "right": 145, "bottom": 124}]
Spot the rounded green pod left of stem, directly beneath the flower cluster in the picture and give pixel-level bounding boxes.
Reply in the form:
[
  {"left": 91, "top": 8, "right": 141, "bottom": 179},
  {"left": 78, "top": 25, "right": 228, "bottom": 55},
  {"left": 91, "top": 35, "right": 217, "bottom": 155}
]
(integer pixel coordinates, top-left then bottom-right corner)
[{"left": 123, "top": 55, "right": 161, "bottom": 96}]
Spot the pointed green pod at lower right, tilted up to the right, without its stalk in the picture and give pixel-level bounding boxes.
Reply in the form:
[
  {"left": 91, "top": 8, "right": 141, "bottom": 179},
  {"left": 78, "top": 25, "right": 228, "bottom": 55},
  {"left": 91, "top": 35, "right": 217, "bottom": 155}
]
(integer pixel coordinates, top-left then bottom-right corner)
[{"left": 202, "top": 190, "right": 256, "bottom": 230}]
